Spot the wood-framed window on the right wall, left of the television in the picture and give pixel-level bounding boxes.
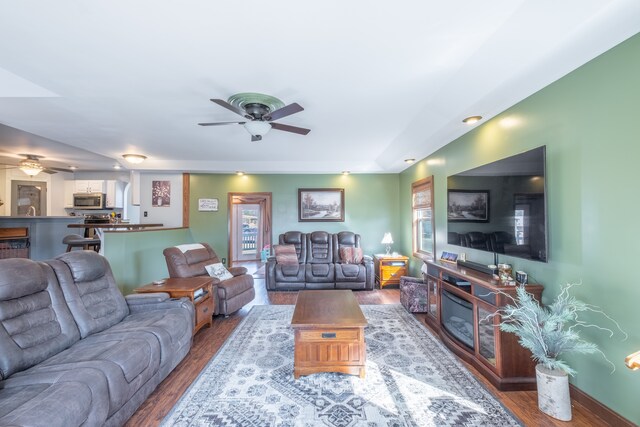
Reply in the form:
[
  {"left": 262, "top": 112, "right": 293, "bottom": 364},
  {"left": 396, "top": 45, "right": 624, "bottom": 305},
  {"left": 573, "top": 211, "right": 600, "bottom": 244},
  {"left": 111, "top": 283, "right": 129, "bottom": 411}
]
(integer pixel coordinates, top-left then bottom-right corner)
[{"left": 411, "top": 176, "right": 435, "bottom": 259}]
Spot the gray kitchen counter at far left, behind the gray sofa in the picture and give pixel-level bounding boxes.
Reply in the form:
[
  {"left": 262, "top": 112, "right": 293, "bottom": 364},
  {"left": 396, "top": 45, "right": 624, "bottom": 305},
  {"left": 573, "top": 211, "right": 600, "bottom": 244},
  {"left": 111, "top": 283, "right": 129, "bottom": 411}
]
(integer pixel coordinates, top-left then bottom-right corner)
[{"left": 0, "top": 216, "right": 84, "bottom": 261}]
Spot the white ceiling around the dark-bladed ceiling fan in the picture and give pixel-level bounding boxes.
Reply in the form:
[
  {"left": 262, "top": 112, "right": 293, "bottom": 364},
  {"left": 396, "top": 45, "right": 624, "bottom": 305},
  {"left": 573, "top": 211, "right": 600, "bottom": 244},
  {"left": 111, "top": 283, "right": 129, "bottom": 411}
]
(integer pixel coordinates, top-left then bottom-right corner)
[{"left": 0, "top": 0, "right": 640, "bottom": 173}]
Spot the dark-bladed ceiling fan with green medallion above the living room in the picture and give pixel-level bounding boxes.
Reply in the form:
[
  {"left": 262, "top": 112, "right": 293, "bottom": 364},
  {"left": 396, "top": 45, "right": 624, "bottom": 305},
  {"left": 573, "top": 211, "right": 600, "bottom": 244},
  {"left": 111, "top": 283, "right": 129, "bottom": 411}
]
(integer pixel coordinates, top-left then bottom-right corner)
[{"left": 198, "top": 93, "right": 311, "bottom": 141}]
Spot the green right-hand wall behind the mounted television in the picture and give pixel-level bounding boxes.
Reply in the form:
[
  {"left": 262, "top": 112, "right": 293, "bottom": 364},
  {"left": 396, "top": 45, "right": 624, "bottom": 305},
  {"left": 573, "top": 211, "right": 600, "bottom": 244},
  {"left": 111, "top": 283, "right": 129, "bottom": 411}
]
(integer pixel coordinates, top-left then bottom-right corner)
[{"left": 400, "top": 35, "right": 640, "bottom": 423}]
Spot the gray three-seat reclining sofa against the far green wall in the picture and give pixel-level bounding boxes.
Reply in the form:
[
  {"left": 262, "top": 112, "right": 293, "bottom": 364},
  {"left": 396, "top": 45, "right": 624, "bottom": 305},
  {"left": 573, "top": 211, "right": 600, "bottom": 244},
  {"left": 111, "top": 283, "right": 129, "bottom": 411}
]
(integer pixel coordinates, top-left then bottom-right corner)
[{"left": 266, "top": 231, "right": 374, "bottom": 291}]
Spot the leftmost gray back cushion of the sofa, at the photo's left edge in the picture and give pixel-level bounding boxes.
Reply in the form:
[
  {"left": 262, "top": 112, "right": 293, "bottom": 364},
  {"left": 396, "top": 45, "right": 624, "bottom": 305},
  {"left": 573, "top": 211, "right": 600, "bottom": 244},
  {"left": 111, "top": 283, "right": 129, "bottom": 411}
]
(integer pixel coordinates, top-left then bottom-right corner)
[{"left": 0, "top": 258, "right": 80, "bottom": 379}]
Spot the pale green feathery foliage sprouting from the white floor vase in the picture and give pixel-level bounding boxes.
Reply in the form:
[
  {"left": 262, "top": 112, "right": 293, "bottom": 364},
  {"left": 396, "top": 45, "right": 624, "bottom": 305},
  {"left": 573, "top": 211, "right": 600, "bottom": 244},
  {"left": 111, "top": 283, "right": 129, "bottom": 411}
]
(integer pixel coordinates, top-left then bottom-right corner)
[{"left": 497, "top": 284, "right": 626, "bottom": 375}]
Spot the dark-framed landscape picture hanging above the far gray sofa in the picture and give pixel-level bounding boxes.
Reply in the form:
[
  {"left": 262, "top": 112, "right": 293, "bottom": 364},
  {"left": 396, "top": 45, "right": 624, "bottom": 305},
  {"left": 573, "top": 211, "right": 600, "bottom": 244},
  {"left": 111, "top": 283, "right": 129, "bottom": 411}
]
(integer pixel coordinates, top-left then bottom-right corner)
[{"left": 298, "top": 188, "right": 344, "bottom": 222}]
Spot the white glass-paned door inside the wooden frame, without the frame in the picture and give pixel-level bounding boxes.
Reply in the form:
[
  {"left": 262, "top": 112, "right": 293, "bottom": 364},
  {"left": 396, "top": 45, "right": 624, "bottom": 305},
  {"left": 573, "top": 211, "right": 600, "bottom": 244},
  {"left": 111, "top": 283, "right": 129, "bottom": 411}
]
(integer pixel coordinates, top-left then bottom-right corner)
[{"left": 232, "top": 203, "right": 262, "bottom": 261}]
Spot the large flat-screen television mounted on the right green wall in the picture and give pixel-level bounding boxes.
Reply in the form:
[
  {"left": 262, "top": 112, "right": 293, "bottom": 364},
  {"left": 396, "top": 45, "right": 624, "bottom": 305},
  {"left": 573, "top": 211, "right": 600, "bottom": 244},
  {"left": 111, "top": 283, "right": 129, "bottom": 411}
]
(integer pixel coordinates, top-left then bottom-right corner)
[{"left": 447, "top": 146, "right": 548, "bottom": 262}]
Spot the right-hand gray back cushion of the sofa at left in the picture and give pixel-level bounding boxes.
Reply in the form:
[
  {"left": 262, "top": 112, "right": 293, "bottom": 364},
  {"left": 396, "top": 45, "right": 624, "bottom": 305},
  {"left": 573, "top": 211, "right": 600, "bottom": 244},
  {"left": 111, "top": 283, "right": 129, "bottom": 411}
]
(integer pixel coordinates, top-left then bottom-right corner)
[{"left": 47, "top": 251, "right": 129, "bottom": 338}]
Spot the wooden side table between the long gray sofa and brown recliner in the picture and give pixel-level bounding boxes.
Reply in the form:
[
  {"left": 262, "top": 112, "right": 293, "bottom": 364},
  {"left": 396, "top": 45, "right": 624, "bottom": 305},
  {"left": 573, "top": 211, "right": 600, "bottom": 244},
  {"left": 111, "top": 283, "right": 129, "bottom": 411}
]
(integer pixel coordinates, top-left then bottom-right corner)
[{"left": 135, "top": 276, "right": 217, "bottom": 335}]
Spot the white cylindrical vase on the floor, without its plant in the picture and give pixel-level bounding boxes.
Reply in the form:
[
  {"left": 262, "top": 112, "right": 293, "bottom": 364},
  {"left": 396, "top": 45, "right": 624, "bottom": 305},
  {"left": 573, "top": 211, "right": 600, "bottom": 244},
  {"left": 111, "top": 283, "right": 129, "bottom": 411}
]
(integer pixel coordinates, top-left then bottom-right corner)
[{"left": 536, "top": 365, "right": 571, "bottom": 421}]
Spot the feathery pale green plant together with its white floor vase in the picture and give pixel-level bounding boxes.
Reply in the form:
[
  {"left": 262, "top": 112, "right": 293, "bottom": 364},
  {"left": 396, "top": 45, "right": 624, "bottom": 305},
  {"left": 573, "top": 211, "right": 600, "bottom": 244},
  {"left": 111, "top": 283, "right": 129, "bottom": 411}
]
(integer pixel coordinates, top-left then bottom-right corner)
[{"left": 497, "top": 284, "right": 627, "bottom": 421}]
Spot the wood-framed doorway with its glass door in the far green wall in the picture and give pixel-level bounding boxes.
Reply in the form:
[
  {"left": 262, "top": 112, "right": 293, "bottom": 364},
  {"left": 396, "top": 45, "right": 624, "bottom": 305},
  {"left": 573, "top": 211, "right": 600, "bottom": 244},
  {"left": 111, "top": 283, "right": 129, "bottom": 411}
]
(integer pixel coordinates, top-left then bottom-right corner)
[{"left": 229, "top": 193, "right": 271, "bottom": 266}]
